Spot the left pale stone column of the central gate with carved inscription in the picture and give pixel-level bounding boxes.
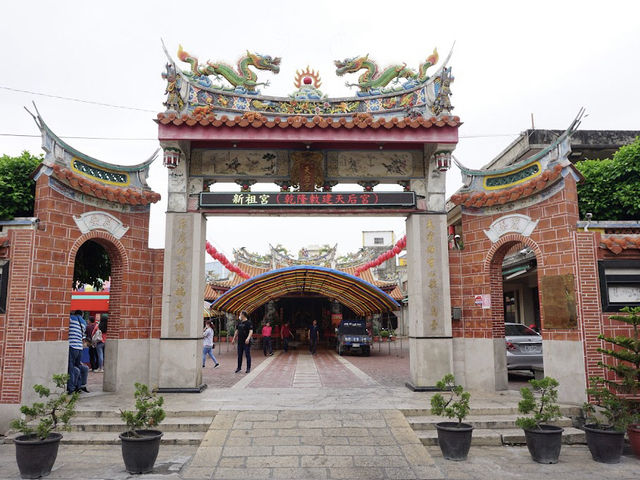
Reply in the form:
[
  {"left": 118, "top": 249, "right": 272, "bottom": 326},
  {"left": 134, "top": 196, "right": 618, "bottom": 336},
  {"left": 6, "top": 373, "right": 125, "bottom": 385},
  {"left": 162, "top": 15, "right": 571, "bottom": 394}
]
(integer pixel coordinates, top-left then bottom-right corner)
[{"left": 158, "top": 213, "right": 206, "bottom": 392}]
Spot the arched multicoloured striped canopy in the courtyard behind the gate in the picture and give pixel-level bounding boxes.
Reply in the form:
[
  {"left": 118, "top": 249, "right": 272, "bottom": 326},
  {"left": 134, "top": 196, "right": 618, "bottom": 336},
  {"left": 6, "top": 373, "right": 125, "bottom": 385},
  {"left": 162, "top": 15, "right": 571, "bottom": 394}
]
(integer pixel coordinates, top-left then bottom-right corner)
[{"left": 211, "top": 266, "right": 399, "bottom": 316}]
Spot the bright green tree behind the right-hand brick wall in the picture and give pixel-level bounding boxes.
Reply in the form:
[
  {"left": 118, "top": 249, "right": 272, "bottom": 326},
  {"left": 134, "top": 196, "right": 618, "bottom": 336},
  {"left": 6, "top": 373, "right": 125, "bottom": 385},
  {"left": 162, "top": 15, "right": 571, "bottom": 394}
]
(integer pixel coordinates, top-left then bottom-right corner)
[{"left": 576, "top": 137, "right": 640, "bottom": 220}]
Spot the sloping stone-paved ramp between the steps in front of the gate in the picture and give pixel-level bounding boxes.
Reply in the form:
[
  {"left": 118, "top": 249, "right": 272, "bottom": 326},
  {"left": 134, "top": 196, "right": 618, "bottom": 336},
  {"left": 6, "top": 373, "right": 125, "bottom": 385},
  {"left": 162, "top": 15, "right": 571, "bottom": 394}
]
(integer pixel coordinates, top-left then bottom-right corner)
[{"left": 183, "top": 410, "right": 433, "bottom": 479}]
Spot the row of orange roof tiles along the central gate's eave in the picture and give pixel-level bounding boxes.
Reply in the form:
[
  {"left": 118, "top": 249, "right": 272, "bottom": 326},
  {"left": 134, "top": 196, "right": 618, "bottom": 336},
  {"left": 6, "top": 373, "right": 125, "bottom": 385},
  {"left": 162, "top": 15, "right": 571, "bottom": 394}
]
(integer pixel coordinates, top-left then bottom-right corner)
[{"left": 158, "top": 112, "right": 461, "bottom": 129}]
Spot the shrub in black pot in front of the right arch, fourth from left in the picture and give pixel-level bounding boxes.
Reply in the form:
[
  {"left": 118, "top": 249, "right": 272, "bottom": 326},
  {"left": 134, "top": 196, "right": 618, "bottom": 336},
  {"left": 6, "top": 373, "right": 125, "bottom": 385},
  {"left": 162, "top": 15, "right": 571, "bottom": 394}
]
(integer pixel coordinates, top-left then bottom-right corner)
[{"left": 516, "top": 377, "right": 564, "bottom": 463}]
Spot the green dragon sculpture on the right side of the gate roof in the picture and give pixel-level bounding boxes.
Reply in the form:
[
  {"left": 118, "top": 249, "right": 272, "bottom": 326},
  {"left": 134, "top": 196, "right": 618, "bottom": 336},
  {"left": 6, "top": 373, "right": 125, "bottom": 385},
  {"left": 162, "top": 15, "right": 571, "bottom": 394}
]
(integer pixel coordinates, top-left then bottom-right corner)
[{"left": 334, "top": 49, "right": 438, "bottom": 96}]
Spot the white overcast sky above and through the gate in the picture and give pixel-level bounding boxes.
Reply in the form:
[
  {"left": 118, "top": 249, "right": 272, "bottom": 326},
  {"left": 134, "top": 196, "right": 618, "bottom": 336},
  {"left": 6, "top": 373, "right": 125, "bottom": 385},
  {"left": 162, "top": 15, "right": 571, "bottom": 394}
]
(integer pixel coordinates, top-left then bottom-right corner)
[{"left": 0, "top": 0, "right": 640, "bottom": 256}]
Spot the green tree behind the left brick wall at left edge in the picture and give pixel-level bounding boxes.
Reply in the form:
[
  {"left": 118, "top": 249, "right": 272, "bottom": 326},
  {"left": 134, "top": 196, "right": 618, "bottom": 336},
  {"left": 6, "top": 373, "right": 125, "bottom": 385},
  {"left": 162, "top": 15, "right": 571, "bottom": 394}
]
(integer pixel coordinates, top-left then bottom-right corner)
[{"left": 0, "top": 150, "right": 42, "bottom": 220}]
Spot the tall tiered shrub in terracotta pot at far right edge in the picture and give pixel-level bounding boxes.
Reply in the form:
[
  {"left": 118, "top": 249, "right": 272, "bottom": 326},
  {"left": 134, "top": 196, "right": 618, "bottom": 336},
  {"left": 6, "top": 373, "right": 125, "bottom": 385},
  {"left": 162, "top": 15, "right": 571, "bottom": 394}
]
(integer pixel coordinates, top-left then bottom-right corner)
[{"left": 589, "top": 307, "right": 640, "bottom": 457}]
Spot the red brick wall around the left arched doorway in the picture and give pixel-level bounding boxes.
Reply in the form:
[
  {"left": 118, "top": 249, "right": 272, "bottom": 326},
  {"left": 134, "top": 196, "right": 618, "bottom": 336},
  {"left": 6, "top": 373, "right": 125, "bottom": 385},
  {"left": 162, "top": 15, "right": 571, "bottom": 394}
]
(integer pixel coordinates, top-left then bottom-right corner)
[{"left": 0, "top": 175, "right": 164, "bottom": 403}]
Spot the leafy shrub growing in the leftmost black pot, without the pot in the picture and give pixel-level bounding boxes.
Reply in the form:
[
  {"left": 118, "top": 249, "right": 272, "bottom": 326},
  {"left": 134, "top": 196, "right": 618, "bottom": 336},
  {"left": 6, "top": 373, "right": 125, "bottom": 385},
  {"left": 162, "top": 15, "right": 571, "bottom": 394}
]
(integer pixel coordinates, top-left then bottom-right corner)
[{"left": 10, "top": 373, "right": 78, "bottom": 440}]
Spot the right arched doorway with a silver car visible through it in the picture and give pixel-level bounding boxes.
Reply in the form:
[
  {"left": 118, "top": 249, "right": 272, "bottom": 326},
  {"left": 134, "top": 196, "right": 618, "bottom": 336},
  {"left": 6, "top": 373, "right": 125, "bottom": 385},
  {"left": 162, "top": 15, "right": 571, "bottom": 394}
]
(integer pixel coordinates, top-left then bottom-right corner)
[{"left": 487, "top": 234, "right": 543, "bottom": 388}]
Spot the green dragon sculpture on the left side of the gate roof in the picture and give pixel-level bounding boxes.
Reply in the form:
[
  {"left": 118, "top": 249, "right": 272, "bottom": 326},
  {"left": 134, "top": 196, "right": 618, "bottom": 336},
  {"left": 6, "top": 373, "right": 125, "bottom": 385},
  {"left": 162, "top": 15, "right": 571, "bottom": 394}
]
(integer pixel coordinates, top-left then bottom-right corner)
[{"left": 178, "top": 45, "right": 280, "bottom": 92}]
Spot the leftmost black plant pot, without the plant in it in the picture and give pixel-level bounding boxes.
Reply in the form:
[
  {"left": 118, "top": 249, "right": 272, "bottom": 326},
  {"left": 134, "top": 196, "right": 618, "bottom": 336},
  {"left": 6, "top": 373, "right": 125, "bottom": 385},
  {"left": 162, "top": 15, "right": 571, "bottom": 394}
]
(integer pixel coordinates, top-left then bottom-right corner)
[{"left": 13, "top": 433, "right": 62, "bottom": 478}]
